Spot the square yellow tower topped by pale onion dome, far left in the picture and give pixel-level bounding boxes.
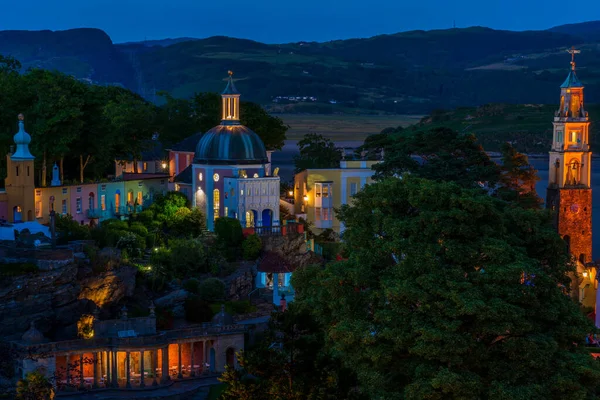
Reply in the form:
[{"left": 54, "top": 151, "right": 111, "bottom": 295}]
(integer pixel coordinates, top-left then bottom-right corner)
[{"left": 5, "top": 114, "right": 35, "bottom": 222}]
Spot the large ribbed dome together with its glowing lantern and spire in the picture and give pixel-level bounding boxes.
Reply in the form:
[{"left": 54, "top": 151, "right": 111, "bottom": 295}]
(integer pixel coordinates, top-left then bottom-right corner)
[{"left": 194, "top": 71, "right": 268, "bottom": 165}]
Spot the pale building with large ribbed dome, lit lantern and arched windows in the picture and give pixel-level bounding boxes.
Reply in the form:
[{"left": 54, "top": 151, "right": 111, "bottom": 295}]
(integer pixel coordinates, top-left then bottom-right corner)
[{"left": 174, "top": 72, "right": 279, "bottom": 230}]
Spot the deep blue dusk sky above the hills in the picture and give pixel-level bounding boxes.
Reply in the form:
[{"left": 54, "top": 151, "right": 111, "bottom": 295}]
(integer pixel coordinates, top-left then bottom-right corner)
[{"left": 0, "top": 0, "right": 600, "bottom": 43}]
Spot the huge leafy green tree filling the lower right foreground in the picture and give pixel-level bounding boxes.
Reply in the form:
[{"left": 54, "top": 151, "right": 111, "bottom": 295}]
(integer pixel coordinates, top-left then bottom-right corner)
[{"left": 293, "top": 175, "right": 600, "bottom": 400}]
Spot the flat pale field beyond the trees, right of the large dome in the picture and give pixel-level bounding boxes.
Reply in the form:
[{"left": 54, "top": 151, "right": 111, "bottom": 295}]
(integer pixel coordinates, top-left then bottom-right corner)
[{"left": 276, "top": 114, "right": 422, "bottom": 140}]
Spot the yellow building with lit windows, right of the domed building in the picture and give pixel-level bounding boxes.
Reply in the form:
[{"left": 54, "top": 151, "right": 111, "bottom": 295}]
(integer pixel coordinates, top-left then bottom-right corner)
[{"left": 294, "top": 160, "right": 379, "bottom": 233}]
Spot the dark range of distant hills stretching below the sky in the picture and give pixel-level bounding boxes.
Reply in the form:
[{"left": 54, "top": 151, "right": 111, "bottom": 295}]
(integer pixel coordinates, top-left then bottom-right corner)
[{"left": 0, "top": 23, "right": 600, "bottom": 114}]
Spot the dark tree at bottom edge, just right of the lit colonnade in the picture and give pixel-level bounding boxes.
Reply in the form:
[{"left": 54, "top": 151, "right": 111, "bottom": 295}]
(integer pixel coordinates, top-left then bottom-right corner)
[{"left": 220, "top": 303, "right": 364, "bottom": 400}]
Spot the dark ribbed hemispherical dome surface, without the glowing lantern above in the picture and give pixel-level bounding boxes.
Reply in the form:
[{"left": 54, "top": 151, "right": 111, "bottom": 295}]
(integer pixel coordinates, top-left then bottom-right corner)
[{"left": 194, "top": 124, "right": 268, "bottom": 165}]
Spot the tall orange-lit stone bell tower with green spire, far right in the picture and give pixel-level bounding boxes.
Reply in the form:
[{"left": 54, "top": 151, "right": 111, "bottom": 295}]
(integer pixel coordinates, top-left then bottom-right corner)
[{"left": 546, "top": 48, "right": 597, "bottom": 307}]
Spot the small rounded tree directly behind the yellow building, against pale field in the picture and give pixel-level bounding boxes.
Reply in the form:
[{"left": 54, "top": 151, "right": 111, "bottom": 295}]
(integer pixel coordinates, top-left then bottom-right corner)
[{"left": 294, "top": 133, "right": 342, "bottom": 172}]
